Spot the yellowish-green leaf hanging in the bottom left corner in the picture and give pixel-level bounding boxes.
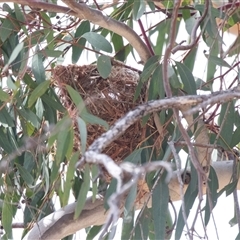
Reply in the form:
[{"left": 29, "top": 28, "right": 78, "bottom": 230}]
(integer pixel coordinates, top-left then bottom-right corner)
[{"left": 1, "top": 194, "right": 13, "bottom": 239}]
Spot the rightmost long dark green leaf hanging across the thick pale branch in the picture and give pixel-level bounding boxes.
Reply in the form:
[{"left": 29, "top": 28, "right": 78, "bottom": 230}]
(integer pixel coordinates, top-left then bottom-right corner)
[{"left": 204, "top": 166, "right": 219, "bottom": 226}]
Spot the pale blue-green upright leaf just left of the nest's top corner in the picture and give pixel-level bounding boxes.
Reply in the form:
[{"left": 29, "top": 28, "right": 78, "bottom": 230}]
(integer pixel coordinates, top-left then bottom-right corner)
[{"left": 32, "top": 45, "right": 46, "bottom": 84}]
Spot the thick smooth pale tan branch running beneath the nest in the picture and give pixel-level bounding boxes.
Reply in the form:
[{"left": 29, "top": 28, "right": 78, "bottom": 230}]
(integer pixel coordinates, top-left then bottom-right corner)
[{"left": 24, "top": 161, "right": 240, "bottom": 240}]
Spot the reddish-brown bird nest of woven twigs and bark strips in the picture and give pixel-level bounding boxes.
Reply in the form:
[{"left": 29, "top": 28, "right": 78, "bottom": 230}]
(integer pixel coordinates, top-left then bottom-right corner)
[{"left": 53, "top": 65, "right": 155, "bottom": 195}]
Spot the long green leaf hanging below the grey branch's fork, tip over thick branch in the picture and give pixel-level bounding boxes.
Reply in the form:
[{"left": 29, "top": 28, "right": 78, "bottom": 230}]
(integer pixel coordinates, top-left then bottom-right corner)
[{"left": 74, "top": 164, "right": 90, "bottom": 219}]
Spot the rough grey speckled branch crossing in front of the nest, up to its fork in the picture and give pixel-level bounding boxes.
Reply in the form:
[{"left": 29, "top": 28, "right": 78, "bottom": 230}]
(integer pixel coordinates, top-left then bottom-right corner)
[{"left": 77, "top": 87, "right": 240, "bottom": 163}]
